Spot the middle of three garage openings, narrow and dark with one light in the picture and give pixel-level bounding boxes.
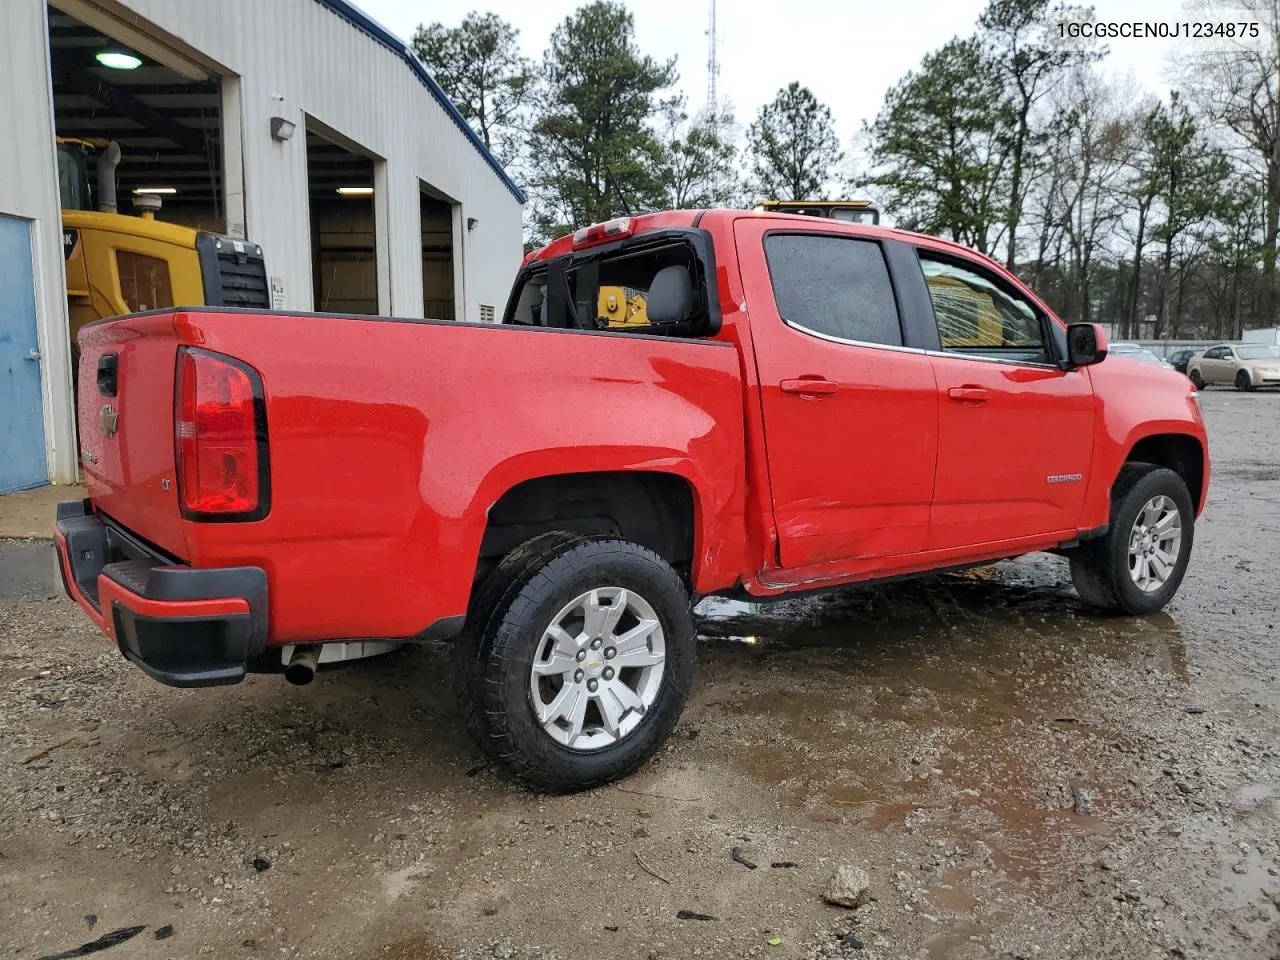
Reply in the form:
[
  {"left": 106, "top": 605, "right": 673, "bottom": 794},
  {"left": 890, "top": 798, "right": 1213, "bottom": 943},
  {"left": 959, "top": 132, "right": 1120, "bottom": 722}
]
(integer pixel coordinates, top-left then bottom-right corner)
[{"left": 307, "top": 128, "right": 379, "bottom": 315}]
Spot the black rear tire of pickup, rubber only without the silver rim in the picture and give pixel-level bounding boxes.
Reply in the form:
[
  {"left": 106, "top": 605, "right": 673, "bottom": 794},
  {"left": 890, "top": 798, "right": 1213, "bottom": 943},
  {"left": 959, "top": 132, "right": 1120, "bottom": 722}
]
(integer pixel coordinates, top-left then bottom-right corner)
[{"left": 456, "top": 534, "right": 696, "bottom": 794}]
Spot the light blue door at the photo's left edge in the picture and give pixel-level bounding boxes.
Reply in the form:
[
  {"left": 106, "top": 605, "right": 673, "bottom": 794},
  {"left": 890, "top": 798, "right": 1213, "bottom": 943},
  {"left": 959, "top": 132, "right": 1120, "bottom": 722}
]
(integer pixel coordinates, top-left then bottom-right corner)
[{"left": 0, "top": 216, "right": 49, "bottom": 493}]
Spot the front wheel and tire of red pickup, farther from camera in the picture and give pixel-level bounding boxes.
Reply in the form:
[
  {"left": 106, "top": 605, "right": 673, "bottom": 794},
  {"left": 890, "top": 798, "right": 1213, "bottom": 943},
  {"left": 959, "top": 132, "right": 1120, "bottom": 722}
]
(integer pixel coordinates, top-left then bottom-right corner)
[{"left": 1071, "top": 463, "right": 1196, "bottom": 613}]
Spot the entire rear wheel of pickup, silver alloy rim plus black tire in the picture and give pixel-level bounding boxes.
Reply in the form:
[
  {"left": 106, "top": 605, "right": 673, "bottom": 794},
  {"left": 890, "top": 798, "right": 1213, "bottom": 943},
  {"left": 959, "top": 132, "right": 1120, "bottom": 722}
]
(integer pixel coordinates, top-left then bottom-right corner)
[{"left": 458, "top": 534, "right": 696, "bottom": 792}]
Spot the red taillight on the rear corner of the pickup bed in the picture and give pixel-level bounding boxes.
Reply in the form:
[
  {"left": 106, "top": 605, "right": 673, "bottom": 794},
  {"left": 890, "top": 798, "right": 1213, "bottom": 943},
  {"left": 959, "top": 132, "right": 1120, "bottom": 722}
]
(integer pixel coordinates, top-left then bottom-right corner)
[{"left": 174, "top": 348, "right": 270, "bottom": 521}]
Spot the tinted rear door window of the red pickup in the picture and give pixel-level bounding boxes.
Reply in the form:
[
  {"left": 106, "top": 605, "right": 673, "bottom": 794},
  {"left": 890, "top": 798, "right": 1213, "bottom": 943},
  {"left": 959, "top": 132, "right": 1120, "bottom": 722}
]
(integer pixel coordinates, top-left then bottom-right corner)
[{"left": 764, "top": 233, "right": 902, "bottom": 347}]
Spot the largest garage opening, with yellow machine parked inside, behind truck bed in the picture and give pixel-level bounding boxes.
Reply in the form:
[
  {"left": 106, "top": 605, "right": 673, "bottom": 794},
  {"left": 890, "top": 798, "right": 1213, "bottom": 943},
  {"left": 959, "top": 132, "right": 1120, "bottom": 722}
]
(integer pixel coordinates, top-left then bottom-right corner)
[{"left": 46, "top": 0, "right": 269, "bottom": 417}]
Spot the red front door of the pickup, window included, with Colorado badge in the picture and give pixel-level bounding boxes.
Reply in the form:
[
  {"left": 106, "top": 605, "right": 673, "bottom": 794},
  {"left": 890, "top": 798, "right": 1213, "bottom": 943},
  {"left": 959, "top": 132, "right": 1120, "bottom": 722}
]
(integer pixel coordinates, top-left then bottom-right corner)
[{"left": 920, "top": 250, "right": 1093, "bottom": 549}]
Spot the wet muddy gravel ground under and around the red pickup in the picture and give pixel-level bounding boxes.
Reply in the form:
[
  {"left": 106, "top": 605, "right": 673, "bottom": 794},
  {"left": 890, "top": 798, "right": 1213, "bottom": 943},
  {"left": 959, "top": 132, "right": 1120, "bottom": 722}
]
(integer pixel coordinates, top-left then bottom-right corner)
[{"left": 0, "top": 390, "right": 1280, "bottom": 960}]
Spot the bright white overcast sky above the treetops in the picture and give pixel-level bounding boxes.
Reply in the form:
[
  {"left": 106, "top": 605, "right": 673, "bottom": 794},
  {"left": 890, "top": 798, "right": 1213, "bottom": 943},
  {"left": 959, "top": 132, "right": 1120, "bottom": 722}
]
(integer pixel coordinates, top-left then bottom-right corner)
[{"left": 356, "top": 0, "right": 1187, "bottom": 146}]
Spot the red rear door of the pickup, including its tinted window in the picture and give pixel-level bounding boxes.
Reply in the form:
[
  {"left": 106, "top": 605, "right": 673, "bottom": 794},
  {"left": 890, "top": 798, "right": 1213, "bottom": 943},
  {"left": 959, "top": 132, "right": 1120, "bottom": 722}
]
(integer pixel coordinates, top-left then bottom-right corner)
[{"left": 735, "top": 218, "right": 938, "bottom": 568}]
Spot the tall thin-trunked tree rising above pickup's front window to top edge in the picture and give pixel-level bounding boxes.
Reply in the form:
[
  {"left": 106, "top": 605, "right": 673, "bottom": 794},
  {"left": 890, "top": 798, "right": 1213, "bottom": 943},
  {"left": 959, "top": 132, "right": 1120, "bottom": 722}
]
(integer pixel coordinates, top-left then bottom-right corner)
[{"left": 978, "top": 0, "right": 1092, "bottom": 270}]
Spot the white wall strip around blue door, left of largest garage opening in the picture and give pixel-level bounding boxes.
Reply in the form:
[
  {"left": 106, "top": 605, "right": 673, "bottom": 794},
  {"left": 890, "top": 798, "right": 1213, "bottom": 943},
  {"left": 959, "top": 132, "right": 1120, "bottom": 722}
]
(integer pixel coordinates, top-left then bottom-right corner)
[{"left": 0, "top": 0, "right": 77, "bottom": 483}]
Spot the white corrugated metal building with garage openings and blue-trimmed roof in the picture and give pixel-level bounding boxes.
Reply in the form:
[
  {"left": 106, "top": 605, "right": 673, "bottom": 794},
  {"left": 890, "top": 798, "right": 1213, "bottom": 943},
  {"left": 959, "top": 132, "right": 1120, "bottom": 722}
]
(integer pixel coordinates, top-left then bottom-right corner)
[{"left": 0, "top": 0, "right": 524, "bottom": 492}]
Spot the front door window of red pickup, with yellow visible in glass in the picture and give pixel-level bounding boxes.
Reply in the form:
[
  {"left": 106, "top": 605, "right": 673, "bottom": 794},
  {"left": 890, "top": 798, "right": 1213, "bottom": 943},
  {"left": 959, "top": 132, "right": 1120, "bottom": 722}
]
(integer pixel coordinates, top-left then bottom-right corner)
[{"left": 920, "top": 252, "right": 1050, "bottom": 364}]
